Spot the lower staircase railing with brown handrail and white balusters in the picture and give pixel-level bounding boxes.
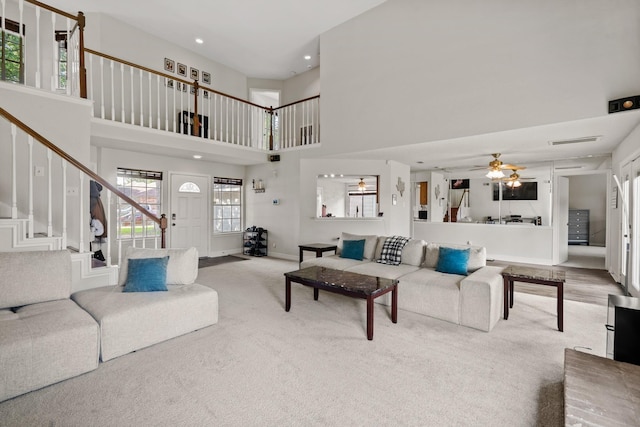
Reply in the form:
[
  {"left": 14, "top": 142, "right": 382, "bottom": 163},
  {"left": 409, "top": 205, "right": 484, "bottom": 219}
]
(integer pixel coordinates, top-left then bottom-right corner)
[{"left": 0, "top": 108, "right": 168, "bottom": 266}]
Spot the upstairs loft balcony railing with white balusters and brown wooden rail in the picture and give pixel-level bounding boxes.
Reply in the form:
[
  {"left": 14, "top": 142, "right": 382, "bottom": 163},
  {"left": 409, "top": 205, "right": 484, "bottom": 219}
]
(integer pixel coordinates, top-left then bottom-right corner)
[{"left": 0, "top": 0, "right": 320, "bottom": 151}]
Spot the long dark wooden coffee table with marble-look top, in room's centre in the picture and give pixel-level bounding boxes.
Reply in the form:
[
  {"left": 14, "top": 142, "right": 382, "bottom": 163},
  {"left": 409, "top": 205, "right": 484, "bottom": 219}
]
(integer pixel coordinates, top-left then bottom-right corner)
[{"left": 284, "top": 266, "right": 398, "bottom": 340}]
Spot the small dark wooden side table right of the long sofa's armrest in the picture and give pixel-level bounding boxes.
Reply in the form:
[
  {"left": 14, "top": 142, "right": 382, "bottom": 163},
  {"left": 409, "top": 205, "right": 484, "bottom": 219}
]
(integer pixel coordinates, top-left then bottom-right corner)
[{"left": 502, "top": 266, "right": 565, "bottom": 332}]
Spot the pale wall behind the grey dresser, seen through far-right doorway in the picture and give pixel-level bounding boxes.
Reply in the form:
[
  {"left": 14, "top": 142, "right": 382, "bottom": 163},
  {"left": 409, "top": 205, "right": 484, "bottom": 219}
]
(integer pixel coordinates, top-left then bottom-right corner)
[{"left": 568, "top": 174, "right": 607, "bottom": 246}]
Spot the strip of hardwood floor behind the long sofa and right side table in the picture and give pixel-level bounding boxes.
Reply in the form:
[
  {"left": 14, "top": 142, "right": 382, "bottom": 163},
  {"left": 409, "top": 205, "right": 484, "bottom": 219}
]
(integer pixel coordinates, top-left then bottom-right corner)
[{"left": 487, "top": 261, "right": 624, "bottom": 306}]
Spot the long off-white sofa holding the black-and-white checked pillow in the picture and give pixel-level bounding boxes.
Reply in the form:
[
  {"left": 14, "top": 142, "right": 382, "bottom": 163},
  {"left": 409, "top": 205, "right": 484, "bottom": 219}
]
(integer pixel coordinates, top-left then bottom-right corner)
[{"left": 300, "top": 233, "right": 504, "bottom": 332}]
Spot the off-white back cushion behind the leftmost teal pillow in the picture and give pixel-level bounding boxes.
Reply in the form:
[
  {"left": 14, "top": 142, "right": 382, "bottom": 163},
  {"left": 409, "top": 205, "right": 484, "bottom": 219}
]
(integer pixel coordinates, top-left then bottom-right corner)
[{"left": 118, "top": 246, "right": 198, "bottom": 285}]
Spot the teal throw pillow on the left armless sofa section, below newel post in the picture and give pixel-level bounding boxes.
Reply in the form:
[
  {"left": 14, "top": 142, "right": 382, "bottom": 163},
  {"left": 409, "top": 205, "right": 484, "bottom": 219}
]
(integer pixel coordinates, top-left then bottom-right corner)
[{"left": 122, "top": 256, "right": 169, "bottom": 292}]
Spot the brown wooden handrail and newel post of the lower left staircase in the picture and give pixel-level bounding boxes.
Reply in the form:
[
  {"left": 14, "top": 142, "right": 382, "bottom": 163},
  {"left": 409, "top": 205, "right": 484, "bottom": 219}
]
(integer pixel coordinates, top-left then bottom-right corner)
[{"left": 0, "top": 107, "right": 167, "bottom": 248}]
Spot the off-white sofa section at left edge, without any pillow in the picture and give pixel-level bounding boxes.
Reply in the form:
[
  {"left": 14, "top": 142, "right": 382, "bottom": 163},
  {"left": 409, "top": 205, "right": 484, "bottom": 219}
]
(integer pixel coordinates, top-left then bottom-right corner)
[{"left": 0, "top": 251, "right": 99, "bottom": 402}]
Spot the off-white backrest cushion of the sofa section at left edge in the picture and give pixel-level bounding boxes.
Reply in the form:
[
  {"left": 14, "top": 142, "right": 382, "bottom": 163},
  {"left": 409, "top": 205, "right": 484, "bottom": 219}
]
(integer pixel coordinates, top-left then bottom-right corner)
[{"left": 0, "top": 250, "right": 71, "bottom": 308}]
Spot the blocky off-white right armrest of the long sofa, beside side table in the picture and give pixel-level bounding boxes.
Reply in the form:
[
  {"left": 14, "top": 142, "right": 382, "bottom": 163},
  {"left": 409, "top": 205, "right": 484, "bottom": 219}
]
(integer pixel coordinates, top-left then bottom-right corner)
[{"left": 460, "top": 266, "right": 504, "bottom": 332}]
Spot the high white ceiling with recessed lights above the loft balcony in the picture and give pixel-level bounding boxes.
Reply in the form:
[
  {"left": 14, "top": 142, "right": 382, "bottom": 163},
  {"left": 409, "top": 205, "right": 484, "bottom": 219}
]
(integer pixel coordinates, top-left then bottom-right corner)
[{"left": 46, "top": 0, "right": 385, "bottom": 80}]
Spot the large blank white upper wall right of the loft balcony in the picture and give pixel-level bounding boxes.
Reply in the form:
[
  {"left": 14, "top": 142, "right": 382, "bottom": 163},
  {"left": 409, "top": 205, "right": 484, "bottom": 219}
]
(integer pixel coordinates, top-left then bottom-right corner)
[{"left": 320, "top": 0, "right": 640, "bottom": 154}]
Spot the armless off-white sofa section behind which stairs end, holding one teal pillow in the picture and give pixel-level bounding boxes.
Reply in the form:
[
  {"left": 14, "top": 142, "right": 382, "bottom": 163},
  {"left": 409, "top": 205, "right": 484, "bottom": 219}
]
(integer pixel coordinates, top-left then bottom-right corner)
[{"left": 71, "top": 247, "right": 218, "bottom": 362}]
